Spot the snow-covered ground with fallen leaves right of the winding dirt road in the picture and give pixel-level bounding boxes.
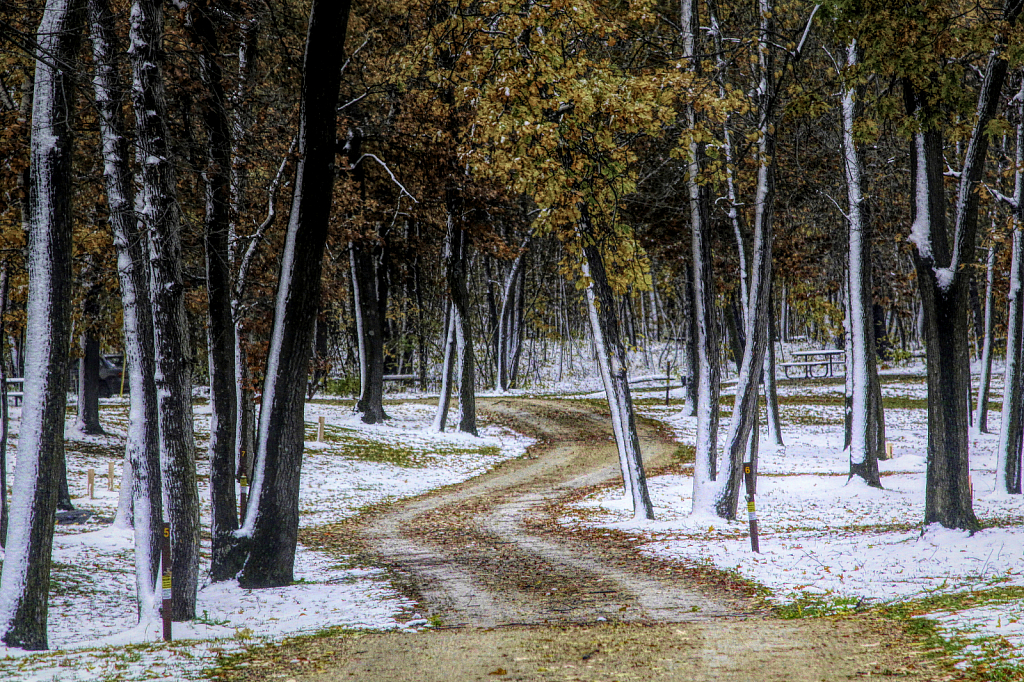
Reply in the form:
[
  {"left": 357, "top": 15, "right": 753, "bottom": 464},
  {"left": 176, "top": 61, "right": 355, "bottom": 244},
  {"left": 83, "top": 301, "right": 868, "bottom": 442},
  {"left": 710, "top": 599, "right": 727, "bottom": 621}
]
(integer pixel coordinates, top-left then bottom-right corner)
[{"left": 564, "top": 358, "right": 1024, "bottom": 663}]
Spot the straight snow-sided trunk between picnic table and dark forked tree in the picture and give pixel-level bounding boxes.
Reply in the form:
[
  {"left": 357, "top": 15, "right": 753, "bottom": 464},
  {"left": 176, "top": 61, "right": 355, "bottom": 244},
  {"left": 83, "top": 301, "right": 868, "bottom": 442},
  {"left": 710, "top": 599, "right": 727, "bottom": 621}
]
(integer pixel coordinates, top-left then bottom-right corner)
[{"left": 842, "top": 41, "right": 882, "bottom": 487}]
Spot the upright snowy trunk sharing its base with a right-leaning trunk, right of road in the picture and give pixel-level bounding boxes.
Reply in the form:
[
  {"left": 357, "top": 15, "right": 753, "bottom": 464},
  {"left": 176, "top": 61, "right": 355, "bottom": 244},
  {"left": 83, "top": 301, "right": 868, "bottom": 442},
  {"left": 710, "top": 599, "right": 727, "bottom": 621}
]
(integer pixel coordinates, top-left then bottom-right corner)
[{"left": 681, "top": 0, "right": 721, "bottom": 514}]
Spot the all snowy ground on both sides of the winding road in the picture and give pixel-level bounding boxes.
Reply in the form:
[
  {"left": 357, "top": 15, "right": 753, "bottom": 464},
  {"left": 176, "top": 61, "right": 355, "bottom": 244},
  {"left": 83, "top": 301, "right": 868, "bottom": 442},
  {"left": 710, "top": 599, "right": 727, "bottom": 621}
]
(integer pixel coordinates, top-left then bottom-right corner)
[{"left": 0, "top": 346, "right": 1024, "bottom": 682}]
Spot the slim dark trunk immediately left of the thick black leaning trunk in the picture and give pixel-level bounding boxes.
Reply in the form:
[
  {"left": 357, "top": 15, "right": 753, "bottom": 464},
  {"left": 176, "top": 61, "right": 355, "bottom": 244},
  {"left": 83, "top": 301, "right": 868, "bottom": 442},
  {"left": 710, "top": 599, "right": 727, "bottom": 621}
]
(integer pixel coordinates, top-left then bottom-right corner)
[{"left": 187, "top": 5, "right": 242, "bottom": 581}]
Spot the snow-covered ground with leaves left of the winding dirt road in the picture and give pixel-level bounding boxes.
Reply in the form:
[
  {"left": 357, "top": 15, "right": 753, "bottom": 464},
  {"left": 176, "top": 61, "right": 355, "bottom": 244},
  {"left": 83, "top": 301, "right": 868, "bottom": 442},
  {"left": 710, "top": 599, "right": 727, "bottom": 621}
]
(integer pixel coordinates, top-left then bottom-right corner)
[{"left": 0, "top": 399, "right": 529, "bottom": 682}]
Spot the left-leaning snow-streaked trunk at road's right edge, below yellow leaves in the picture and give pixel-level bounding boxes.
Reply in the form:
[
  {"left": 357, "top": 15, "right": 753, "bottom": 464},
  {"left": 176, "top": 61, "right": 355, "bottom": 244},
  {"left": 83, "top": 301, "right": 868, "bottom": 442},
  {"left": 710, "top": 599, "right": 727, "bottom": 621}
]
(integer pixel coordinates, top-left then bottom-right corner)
[{"left": 581, "top": 219, "right": 654, "bottom": 519}]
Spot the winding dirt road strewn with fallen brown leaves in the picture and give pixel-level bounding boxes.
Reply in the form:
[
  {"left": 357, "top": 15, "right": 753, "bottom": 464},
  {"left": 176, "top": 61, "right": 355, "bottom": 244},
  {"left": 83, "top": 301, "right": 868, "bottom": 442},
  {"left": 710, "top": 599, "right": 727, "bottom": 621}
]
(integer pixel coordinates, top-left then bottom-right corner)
[{"left": 251, "top": 399, "right": 937, "bottom": 682}]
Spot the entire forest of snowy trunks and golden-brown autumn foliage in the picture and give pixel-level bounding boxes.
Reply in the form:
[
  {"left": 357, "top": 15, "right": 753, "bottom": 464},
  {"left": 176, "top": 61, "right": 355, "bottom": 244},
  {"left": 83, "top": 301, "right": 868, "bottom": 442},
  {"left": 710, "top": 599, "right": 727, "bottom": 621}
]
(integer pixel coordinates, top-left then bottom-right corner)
[{"left": 0, "top": 0, "right": 1024, "bottom": 648}]
